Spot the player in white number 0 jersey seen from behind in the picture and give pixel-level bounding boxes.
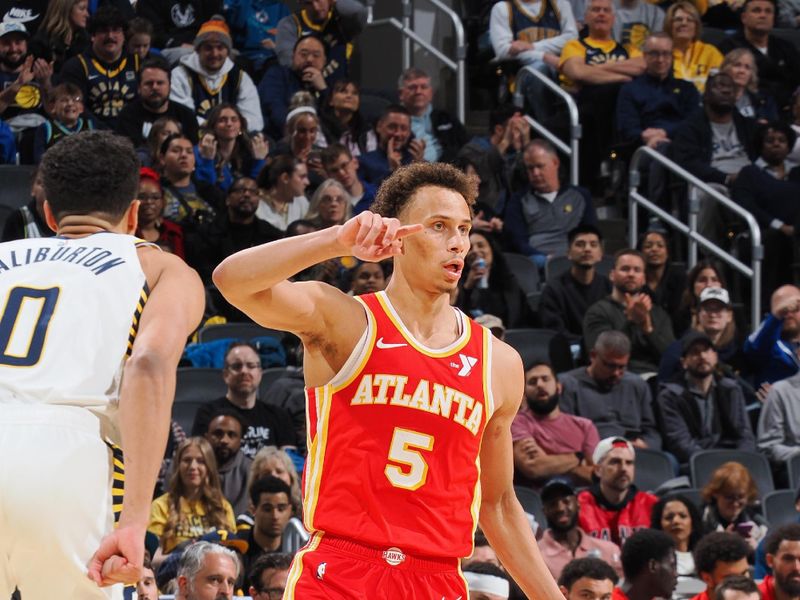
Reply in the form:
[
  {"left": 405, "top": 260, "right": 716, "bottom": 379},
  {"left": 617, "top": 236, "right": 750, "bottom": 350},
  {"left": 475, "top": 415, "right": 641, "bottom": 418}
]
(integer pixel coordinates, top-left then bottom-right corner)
[{"left": 0, "top": 132, "right": 203, "bottom": 600}]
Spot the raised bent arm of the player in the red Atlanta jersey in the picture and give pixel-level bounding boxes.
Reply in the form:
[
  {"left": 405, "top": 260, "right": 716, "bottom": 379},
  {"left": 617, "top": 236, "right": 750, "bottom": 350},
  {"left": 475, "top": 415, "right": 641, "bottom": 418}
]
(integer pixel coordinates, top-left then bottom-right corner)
[{"left": 214, "top": 212, "right": 422, "bottom": 337}]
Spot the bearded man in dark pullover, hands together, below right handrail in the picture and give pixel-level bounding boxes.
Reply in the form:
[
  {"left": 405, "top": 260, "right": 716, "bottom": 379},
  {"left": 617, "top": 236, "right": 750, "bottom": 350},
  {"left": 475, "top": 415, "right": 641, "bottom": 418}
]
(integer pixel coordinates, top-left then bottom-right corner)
[{"left": 583, "top": 249, "right": 675, "bottom": 374}]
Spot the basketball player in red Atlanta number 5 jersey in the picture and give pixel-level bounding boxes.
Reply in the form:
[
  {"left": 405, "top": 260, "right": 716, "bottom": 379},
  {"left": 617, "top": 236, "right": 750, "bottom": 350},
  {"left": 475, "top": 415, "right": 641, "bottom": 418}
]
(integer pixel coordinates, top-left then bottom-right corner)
[{"left": 214, "top": 163, "right": 562, "bottom": 600}]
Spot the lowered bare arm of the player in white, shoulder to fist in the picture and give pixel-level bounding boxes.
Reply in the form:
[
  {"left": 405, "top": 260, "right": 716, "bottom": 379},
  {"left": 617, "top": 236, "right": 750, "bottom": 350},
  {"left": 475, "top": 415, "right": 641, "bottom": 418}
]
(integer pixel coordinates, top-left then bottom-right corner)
[{"left": 89, "top": 248, "right": 205, "bottom": 585}]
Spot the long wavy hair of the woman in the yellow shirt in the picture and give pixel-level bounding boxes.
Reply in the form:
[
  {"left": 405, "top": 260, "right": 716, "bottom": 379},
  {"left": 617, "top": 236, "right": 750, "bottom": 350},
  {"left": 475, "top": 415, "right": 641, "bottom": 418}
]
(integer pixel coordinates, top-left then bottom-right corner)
[{"left": 161, "top": 437, "right": 234, "bottom": 552}]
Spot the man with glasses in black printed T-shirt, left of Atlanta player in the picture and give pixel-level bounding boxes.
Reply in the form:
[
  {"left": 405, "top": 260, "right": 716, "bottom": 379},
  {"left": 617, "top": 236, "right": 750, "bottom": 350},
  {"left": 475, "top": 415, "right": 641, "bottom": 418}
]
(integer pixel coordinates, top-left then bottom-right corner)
[{"left": 192, "top": 342, "right": 295, "bottom": 458}]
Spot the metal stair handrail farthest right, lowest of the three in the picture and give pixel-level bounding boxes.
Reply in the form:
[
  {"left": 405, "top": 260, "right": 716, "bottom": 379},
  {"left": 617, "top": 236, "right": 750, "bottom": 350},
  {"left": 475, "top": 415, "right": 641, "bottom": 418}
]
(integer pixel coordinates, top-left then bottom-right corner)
[{"left": 628, "top": 146, "right": 764, "bottom": 330}]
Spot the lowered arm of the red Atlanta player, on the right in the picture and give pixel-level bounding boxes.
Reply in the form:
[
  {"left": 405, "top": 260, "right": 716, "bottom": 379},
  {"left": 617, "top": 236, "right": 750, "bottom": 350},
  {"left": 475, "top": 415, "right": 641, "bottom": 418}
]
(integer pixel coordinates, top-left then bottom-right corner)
[{"left": 480, "top": 340, "right": 563, "bottom": 600}]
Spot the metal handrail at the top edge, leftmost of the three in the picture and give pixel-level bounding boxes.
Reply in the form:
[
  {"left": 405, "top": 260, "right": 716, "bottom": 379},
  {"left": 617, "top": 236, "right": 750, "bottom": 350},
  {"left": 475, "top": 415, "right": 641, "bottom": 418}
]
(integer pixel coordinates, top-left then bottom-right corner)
[{"left": 366, "top": 0, "right": 467, "bottom": 123}]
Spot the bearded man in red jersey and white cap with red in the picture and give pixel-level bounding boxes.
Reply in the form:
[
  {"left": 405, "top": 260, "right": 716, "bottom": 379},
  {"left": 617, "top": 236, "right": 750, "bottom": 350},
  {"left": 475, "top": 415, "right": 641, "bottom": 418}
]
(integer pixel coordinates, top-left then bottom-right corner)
[{"left": 578, "top": 437, "right": 670, "bottom": 544}]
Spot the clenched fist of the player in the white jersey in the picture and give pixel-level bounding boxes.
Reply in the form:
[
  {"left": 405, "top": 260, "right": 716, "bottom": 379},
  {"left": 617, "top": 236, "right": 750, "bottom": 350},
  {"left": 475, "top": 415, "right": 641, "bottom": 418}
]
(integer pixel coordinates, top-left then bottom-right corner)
[{"left": 89, "top": 526, "right": 145, "bottom": 587}]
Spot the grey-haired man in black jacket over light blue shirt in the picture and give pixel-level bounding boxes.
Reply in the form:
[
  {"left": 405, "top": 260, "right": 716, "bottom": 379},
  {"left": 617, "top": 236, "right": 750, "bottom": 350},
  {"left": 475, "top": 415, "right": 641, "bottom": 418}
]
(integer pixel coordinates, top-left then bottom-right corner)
[{"left": 398, "top": 67, "right": 469, "bottom": 162}]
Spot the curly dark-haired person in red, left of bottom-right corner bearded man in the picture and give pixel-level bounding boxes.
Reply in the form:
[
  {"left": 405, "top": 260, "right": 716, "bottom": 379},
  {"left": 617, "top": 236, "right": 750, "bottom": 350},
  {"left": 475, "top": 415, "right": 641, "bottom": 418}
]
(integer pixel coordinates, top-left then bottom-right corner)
[{"left": 692, "top": 531, "right": 752, "bottom": 600}]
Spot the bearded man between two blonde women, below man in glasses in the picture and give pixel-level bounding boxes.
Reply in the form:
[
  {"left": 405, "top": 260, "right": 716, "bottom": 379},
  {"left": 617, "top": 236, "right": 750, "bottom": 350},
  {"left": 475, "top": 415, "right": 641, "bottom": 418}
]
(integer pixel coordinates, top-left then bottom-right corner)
[{"left": 205, "top": 408, "right": 253, "bottom": 515}]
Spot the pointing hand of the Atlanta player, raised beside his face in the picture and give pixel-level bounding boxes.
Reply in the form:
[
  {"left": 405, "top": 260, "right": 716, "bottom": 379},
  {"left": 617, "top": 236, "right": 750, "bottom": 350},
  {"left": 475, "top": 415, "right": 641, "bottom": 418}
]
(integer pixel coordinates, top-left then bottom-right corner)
[{"left": 337, "top": 211, "right": 423, "bottom": 262}]
